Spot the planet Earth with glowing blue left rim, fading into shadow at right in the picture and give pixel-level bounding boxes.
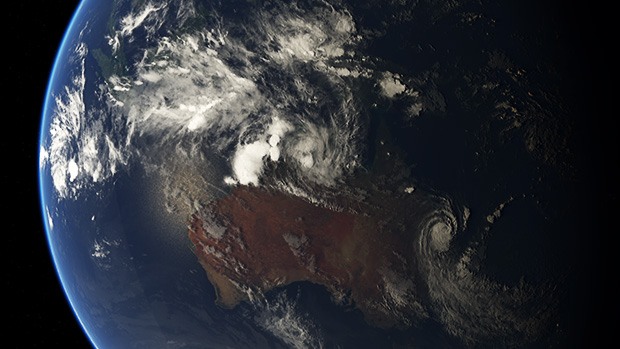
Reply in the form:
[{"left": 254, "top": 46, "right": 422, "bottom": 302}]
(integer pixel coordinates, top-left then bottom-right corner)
[{"left": 39, "top": 0, "right": 596, "bottom": 348}]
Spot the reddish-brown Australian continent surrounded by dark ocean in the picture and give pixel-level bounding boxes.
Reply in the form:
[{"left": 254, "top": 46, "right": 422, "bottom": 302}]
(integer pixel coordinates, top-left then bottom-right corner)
[{"left": 189, "top": 186, "right": 425, "bottom": 327}]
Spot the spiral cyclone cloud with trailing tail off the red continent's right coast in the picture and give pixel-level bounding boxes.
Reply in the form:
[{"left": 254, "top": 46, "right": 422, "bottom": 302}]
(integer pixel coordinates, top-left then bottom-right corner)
[{"left": 415, "top": 197, "right": 552, "bottom": 346}]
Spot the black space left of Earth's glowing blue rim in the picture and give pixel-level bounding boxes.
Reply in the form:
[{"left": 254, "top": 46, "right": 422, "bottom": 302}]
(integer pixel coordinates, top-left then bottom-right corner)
[{"left": 0, "top": 0, "right": 92, "bottom": 348}]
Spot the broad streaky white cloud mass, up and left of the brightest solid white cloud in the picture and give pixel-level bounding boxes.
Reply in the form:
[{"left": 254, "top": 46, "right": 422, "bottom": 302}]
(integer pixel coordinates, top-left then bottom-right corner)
[{"left": 117, "top": 34, "right": 266, "bottom": 146}]
